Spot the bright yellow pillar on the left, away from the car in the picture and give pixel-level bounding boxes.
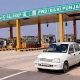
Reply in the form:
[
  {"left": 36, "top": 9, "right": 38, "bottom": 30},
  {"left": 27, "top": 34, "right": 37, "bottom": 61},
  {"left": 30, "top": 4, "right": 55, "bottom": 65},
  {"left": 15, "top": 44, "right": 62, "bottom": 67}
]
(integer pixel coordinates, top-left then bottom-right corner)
[{"left": 16, "top": 19, "right": 21, "bottom": 49}]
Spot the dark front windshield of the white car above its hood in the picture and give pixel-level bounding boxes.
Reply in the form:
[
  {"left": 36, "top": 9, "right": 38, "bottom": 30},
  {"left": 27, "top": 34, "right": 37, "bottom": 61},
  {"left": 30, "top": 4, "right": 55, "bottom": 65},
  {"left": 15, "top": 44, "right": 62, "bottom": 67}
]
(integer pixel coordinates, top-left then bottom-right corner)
[{"left": 44, "top": 44, "right": 68, "bottom": 53}]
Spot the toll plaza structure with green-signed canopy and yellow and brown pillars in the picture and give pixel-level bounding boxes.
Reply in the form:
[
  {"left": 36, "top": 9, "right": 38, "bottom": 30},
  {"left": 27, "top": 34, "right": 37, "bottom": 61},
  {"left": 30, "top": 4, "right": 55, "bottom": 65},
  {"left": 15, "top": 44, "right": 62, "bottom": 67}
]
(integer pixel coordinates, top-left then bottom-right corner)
[{"left": 0, "top": 2, "right": 80, "bottom": 50}]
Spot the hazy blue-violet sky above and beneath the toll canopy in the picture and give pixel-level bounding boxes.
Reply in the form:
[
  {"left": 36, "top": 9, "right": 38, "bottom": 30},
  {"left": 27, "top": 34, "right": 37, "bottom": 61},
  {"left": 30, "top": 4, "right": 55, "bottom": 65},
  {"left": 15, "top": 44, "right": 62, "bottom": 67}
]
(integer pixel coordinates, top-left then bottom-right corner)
[{"left": 0, "top": 0, "right": 80, "bottom": 38}]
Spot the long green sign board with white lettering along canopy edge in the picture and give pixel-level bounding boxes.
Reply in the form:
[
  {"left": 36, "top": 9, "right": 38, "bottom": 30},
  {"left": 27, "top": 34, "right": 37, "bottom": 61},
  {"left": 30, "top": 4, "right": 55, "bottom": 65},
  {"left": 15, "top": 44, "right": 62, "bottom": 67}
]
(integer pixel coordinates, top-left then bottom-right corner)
[{"left": 0, "top": 2, "right": 80, "bottom": 21}]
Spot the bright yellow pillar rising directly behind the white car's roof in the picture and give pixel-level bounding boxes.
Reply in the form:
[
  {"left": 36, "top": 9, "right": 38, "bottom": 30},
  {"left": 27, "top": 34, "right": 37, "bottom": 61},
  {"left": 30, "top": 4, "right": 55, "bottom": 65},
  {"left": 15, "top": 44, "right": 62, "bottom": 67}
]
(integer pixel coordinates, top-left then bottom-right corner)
[{"left": 59, "top": 14, "right": 64, "bottom": 42}]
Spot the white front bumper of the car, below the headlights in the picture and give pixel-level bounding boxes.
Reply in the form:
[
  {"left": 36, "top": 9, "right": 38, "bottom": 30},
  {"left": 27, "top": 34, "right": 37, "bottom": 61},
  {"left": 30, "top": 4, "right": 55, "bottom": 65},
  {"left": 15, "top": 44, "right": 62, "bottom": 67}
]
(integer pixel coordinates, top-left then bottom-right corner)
[{"left": 35, "top": 63, "right": 63, "bottom": 70}]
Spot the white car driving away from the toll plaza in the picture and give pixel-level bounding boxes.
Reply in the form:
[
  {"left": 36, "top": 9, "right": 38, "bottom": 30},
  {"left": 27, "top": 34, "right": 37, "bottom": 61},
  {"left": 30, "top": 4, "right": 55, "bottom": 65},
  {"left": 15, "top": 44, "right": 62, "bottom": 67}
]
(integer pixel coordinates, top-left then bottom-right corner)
[{"left": 35, "top": 42, "right": 80, "bottom": 72}]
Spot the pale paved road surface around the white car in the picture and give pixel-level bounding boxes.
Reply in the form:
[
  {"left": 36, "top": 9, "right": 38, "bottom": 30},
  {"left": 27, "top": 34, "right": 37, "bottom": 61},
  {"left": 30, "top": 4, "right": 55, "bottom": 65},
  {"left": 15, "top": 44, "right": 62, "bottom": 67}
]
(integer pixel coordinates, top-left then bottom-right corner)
[{"left": 0, "top": 50, "right": 80, "bottom": 80}]
